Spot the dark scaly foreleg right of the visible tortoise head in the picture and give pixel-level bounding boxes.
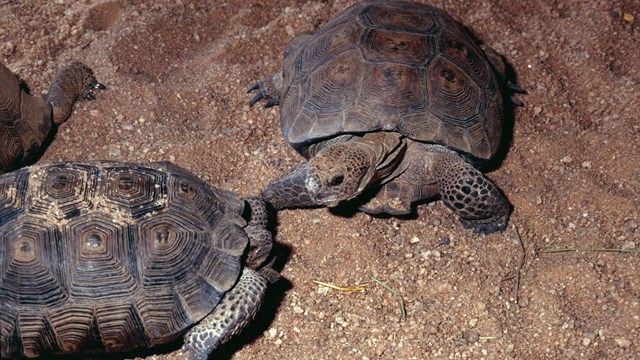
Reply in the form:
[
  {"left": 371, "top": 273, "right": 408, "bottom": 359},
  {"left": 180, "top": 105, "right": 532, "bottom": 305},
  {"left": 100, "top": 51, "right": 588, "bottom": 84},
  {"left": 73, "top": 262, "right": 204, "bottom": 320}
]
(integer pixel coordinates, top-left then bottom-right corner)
[{"left": 429, "top": 145, "right": 511, "bottom": 234}]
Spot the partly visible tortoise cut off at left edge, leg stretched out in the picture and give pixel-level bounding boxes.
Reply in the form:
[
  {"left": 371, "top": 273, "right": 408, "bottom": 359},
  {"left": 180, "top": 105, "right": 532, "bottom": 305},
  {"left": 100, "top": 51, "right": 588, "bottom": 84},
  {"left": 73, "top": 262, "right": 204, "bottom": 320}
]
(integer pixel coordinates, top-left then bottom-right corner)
[{"left": 0, "top": 61, "right": 106, "bottom": 174}]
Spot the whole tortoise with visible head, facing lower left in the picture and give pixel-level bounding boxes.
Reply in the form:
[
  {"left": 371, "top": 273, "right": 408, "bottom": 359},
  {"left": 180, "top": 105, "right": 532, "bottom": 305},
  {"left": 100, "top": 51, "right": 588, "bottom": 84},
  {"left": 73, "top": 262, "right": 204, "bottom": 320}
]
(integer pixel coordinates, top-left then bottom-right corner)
[{"left": 248, "top": 0, "right": 522, "bottom": 233}]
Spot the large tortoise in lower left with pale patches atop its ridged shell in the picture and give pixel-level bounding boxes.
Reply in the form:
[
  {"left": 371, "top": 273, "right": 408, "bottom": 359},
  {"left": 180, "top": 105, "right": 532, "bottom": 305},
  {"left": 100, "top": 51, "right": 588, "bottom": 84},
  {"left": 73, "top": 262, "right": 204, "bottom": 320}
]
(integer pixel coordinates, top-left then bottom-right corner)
[{"left": 0, "top": 161, "right": 279, "bottom": 359}]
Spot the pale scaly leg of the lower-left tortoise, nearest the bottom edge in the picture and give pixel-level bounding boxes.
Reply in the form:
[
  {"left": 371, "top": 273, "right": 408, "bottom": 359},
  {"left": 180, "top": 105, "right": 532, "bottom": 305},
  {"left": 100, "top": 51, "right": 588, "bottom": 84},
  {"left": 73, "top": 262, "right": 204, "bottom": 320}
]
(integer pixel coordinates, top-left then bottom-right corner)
[{"left": 182, "top": 267, "right": 267, "bottom": 360}]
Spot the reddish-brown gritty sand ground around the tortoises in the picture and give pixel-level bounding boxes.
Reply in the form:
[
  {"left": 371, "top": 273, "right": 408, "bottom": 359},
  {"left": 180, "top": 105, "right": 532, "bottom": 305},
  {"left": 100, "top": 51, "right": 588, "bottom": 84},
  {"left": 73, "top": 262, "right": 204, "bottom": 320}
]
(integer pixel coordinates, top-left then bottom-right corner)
[{"left": 0, "top": 0, "right": 640, "bottom": 360}]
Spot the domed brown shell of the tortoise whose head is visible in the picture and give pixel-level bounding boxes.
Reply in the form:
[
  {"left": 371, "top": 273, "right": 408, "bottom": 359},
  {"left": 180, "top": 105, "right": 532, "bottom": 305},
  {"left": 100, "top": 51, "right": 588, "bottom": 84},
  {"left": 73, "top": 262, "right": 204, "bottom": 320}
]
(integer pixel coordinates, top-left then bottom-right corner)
[{"left": 281, "top": 1, "right": 503, "bottom": 160}]
